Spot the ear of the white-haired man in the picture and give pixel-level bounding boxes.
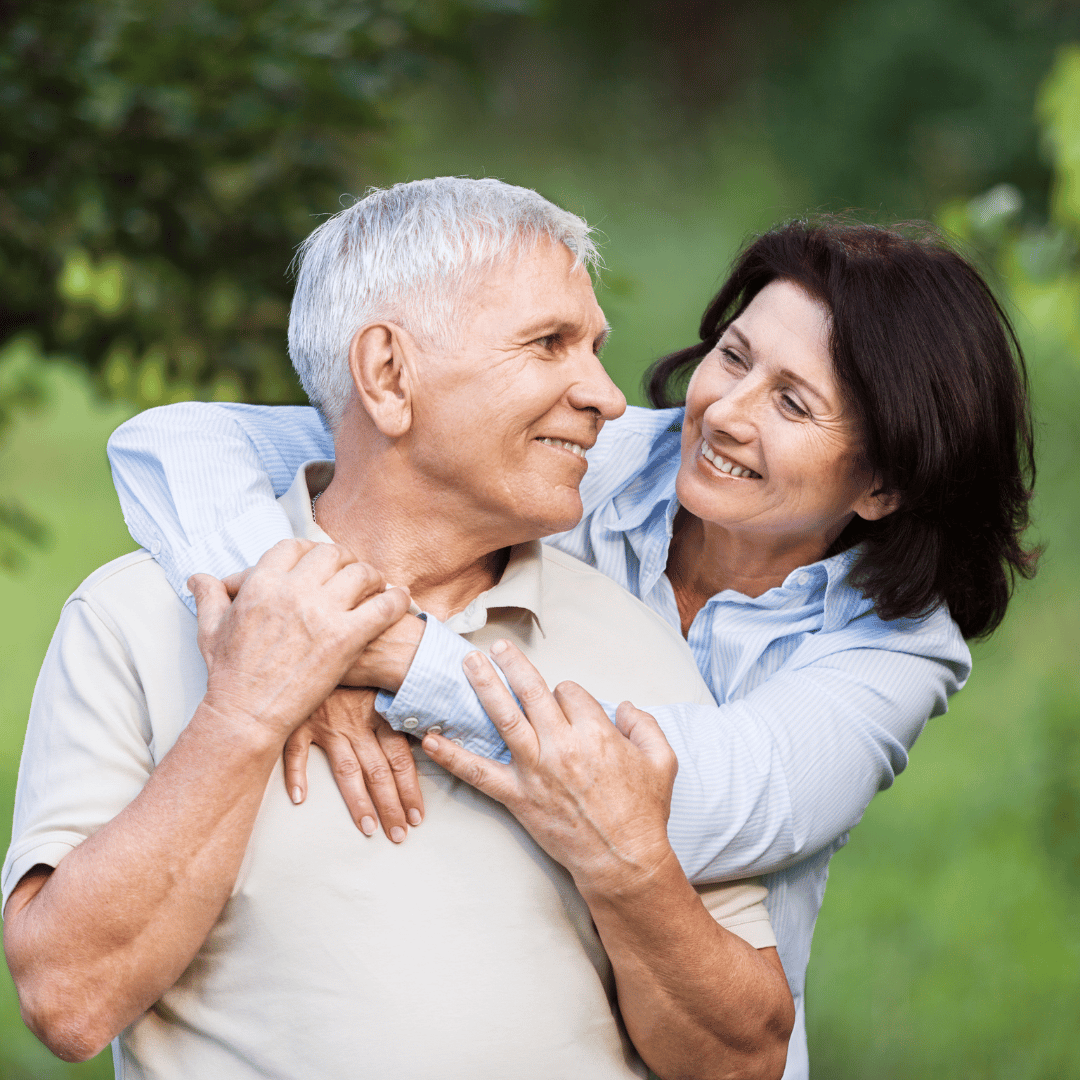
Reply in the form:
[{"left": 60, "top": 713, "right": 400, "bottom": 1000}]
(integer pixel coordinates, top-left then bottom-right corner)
[{"left": 349, "top": 323, "right": 416, "bottom": 438}]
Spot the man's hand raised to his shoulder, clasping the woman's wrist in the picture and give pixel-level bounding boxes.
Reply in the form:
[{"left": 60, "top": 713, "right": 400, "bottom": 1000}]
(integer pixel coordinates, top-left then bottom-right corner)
[{"left": 188, "top": 540, "right": 409, "bottom": 742}]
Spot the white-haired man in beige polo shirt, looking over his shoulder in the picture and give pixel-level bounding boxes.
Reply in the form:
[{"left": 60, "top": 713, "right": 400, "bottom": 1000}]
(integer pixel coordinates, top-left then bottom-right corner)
[{"left": 3, "top": 179, "right": 791, "bottom": 1080}]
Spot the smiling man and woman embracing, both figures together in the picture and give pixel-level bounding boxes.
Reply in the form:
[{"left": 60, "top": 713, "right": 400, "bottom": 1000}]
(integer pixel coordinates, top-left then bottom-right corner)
[{"left": 2, "top": 177, "right": 1035, "bottom": 1080}]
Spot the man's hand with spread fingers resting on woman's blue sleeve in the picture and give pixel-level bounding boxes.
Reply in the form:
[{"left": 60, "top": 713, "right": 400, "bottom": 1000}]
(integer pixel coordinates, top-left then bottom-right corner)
[{"left": 423, "top": 642, "right": 678, "bottom": 901}]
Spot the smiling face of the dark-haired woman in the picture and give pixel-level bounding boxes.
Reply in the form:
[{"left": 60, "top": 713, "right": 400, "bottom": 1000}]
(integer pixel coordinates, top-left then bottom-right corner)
[{"left": 677, "top": 274, "right": 892, "bottom": 563}]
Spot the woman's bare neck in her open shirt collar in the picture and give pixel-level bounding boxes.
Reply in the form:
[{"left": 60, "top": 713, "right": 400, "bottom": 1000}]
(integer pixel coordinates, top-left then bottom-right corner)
[{"left": 666, "top": 508, "right": 823, "bottom": 637}]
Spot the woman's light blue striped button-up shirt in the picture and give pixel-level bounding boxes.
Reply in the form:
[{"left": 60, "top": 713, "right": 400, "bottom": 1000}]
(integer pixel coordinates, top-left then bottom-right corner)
[{"left": 109, "top": 403, "right": 971, "bottom": 1080}]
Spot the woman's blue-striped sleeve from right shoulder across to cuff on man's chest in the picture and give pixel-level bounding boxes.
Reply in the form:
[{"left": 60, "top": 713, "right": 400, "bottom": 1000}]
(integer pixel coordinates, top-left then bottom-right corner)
[{"left": 362, "top": 612, "right": 970, "bottom": 882}]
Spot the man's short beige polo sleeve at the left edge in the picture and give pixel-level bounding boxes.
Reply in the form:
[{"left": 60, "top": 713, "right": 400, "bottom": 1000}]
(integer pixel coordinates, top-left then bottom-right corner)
[{"left": 0, "top": 599, "right": 153, "bottom": 907}]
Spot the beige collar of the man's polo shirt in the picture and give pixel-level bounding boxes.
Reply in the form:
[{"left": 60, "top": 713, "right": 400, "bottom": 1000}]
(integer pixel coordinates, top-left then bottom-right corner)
[{"left": 278, "top": 460, "right": 544, "bottom": 635}]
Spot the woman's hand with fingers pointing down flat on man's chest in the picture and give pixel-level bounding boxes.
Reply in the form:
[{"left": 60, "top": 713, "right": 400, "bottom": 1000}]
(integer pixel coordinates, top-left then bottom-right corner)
[{"left": 285, "top": 687, "right": 423, "bottom": 843}]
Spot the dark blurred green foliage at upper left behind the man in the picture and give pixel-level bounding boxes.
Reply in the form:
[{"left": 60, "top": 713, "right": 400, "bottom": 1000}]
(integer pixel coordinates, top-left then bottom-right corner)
[{"left": 0, "top": 0, "right": 516, "bottom": 406}]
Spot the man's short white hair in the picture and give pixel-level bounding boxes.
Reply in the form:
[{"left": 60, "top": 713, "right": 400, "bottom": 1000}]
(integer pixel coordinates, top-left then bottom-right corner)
[{"left": 288, "top": 176, "right": 599, "bottom": 431}]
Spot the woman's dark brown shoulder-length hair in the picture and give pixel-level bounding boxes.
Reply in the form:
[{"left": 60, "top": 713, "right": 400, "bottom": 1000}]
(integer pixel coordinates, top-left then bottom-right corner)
[{"left": 646, "top": 218, "right": 1038, "bottom": 637}]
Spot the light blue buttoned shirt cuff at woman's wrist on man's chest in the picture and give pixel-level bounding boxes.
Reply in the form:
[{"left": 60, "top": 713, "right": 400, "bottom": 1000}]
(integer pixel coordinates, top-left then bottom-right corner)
[{"left": 375, "top": 616, "right": 510, "bottom": 761}]
